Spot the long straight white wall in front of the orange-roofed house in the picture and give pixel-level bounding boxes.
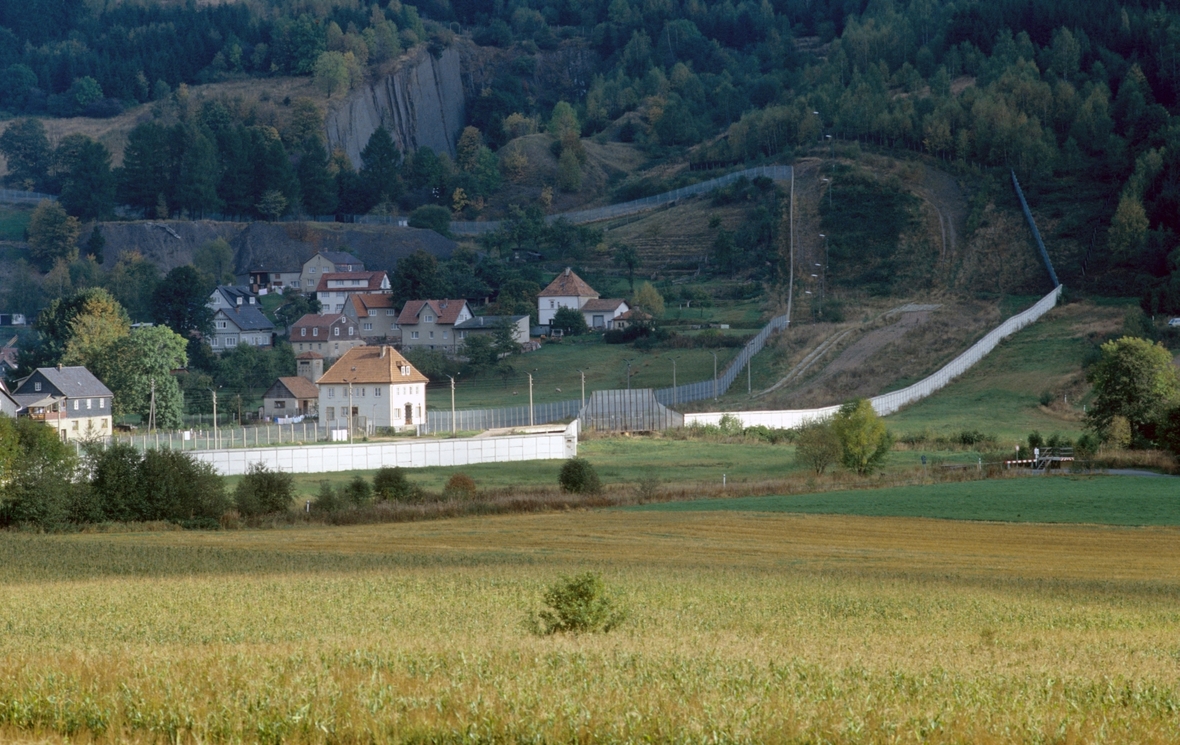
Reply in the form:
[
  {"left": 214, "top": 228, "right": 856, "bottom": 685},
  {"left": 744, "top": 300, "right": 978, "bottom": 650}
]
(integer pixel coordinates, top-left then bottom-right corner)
[{"left": 192, "top": 419, "right": 578, "bottom": 476}]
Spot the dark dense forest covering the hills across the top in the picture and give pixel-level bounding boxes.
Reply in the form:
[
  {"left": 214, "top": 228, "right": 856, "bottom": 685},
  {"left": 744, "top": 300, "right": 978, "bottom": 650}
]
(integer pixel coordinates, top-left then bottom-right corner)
[{"left": 0, "top": 0, "right": 1180, "bottom": 313}]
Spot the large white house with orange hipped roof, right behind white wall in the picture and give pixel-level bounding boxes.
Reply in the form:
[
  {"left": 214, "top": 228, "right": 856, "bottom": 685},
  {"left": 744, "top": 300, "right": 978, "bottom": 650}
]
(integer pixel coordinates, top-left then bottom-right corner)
[{"left": 316, "top": 345, "right": 430, "bottom": 433}]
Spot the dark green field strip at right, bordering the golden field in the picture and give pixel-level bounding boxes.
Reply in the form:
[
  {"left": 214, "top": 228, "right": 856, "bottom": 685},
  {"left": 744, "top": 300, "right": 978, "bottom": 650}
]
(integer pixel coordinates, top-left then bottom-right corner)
[{"left": 623, "top": 476, "right": 1180, "bottom": 525}]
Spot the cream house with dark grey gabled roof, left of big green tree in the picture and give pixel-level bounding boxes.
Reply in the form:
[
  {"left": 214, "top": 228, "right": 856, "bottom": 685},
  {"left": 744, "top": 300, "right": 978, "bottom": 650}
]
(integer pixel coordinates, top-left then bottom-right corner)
[{"left": 12, "top": 365, "right": 114, "bottom": 440}]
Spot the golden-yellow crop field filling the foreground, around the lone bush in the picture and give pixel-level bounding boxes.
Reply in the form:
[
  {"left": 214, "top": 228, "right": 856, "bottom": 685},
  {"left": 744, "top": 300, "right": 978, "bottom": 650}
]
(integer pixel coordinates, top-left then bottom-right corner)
[{"left": 0, "top": 479, "right": 1180, "bottom": 743}]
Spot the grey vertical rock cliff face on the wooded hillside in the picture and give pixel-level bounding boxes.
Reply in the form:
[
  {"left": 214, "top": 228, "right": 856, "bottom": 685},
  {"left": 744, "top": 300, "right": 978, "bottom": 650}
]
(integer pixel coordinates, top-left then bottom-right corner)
[{"left": 325, "top": 47, "right": 465, "bottom": 168}]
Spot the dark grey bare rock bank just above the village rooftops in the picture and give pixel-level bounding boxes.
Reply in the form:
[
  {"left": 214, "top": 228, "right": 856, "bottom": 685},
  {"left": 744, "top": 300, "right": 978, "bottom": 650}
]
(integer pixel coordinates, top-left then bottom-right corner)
[{"left": 93, "top": 220, "right": 455, "bottom": 275}]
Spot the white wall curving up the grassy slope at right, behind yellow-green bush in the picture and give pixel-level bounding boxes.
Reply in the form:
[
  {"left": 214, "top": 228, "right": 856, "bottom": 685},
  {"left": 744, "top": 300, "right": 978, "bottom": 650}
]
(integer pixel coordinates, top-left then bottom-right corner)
[{"left": 684, "top": 290, "right": 1062, "bottom": 429}]
